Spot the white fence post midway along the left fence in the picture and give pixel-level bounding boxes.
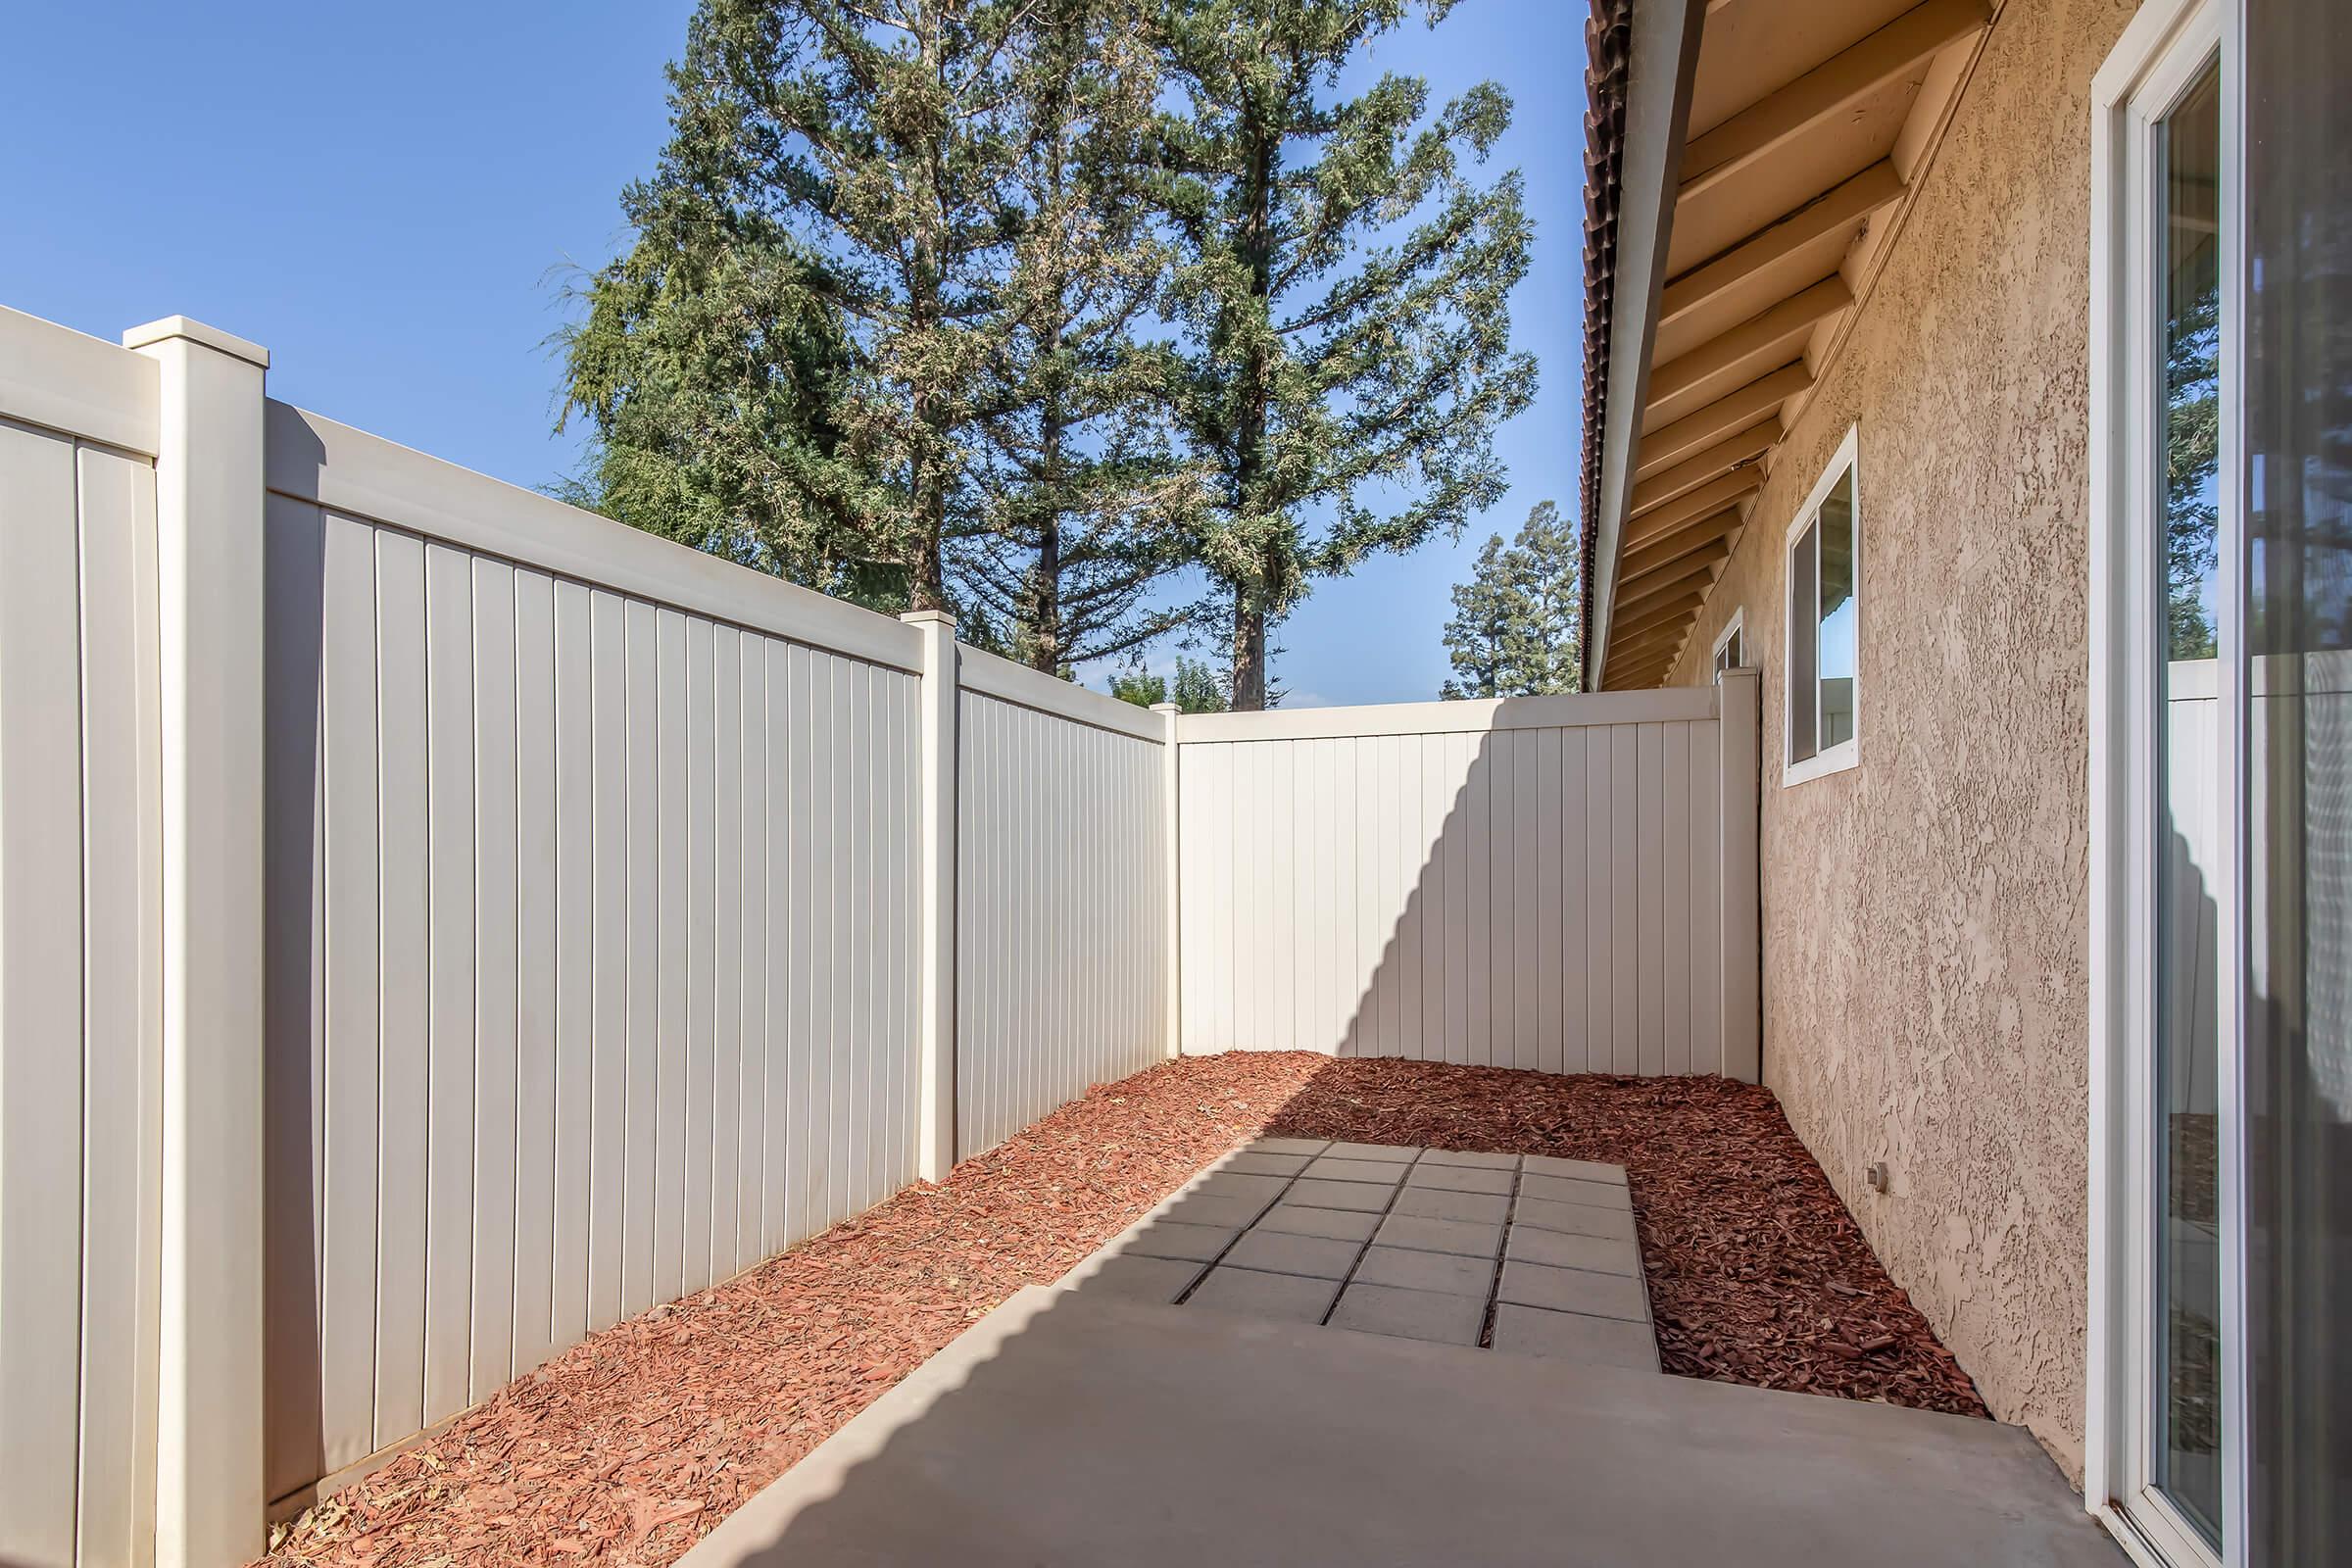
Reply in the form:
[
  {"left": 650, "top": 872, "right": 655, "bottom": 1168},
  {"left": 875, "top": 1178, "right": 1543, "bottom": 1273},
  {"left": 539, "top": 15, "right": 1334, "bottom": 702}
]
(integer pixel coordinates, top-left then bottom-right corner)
[{"left": 899, "top": 609, "right": 957, "bottom": 1183}]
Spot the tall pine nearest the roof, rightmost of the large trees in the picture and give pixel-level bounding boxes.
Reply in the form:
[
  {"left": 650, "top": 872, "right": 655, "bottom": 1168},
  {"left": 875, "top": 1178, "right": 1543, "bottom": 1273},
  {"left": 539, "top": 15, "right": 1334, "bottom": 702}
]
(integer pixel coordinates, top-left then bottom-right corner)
[{"left": 1162, "top": 0, "right": 1536, "bottom": 710}]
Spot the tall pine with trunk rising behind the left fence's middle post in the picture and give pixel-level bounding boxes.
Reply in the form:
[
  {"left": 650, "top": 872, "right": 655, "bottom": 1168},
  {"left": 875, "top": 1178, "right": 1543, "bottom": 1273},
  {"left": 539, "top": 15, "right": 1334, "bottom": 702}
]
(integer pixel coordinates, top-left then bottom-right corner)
[{"left": 574, "top": 0, "right": 1035, "bottom": 609}]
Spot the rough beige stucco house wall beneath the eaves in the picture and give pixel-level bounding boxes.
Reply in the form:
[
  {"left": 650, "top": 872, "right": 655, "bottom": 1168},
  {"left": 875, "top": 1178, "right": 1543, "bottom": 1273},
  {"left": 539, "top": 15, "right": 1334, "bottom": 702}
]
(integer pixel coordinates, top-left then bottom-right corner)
[{"left": 1675, "top": 0, "right": 2133, "bottom": 1481}]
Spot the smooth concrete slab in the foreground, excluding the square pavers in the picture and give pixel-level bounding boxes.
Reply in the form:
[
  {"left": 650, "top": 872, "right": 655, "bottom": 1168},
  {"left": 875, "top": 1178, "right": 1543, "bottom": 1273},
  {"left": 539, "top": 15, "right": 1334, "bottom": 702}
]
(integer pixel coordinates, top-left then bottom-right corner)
[{"left": 684, "top": 1286, "right": 2124, "bottom": 1568}]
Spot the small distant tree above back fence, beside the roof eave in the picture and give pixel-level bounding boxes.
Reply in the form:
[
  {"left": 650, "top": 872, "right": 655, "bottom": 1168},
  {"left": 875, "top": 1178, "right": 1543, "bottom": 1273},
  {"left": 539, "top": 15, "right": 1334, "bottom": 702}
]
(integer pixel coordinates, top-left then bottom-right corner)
[{"left": 1440, "top": 501, "right": 1583, "bottom": 698}]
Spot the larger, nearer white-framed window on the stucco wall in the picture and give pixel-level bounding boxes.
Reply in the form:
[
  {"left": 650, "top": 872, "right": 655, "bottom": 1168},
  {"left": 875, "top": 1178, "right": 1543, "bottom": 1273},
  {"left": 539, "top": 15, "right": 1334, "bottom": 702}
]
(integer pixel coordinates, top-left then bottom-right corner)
[{"left": 1781, "top": 430, "right": 1863, "bottom": 785}]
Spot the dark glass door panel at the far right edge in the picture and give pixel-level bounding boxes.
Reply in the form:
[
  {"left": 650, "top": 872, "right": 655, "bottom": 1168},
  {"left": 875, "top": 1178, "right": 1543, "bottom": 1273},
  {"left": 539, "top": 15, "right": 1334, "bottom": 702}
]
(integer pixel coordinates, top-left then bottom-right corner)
[{"left": 2239, "top": 0, "right": 2352, "bottom": 1563}]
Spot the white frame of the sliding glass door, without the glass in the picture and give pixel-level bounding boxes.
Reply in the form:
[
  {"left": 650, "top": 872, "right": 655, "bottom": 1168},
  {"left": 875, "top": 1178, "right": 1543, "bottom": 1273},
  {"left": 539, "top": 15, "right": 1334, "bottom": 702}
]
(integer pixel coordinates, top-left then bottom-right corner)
[{"left": 2083, "top": 0, "right": 2251, "bottom": 1568}]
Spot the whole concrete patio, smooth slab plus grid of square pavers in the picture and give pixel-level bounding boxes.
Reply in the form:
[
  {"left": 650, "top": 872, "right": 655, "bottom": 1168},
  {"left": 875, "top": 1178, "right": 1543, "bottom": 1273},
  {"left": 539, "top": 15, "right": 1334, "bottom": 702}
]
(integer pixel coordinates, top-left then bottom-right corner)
[{"left": 684, "top": 1138, "right": 2122, "bottom": 1568}]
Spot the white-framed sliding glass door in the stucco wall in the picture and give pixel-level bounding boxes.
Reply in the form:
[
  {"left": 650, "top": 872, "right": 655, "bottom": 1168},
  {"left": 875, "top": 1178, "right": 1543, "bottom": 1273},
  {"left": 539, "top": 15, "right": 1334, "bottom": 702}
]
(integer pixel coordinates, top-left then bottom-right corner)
[{"left": 2086, "top": 0, "right": 2352, "bottom": 1568}]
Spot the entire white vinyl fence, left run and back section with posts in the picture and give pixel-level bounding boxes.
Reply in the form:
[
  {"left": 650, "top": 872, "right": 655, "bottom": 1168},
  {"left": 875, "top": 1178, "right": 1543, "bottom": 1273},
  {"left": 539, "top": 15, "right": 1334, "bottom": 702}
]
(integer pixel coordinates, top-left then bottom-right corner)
[{"left": 0, "top": 311, "right": 1754, "bottom": 1568}]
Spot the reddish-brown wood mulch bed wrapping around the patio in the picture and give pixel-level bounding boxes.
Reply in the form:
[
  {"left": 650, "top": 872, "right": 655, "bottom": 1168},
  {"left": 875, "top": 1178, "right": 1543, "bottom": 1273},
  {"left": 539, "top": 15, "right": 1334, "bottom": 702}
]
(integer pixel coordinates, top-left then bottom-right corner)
[{"left": 264, "top": 1054, "right": 1985, "bottom": 1568}]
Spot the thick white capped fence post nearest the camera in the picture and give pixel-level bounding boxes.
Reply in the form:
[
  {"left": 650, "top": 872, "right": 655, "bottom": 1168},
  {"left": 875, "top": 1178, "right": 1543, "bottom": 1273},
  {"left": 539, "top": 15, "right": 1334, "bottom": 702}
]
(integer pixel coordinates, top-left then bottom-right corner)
[{"left": 122, "top": 315, "right": 270, "bottom": 1568}]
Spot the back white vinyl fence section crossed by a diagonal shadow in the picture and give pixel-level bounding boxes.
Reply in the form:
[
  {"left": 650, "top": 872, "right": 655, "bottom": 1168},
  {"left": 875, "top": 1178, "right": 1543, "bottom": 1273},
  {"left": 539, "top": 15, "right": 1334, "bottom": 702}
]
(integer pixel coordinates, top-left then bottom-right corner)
[{"left": 1178, "top": 677, "right": 1757, "bottom": 1079}]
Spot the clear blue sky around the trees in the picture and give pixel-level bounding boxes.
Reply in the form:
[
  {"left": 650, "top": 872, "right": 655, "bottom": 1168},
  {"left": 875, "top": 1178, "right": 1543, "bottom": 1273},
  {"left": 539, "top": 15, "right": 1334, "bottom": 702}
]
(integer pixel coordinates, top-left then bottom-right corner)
[{"left": 0, "top": 0, "right": 1583, "bottom": 706}]
